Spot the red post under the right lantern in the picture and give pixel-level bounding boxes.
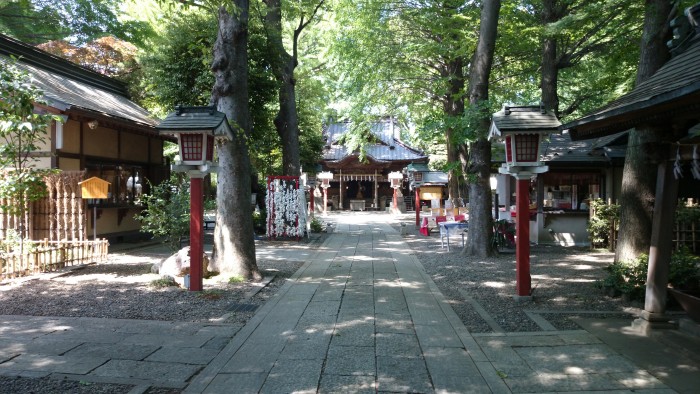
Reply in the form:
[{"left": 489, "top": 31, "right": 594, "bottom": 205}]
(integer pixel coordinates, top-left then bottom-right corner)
[{"left": 515, "top": 178, "right": 530, "bottom": 297}]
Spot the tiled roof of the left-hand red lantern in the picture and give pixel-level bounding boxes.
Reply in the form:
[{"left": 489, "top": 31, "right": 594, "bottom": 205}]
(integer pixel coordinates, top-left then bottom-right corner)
[{"left": 156, "top": 106, "right": 233, "bottom": 137}]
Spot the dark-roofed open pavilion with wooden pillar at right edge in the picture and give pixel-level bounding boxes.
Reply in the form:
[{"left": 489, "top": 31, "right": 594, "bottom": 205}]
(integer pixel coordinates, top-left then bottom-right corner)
[{"left": 561, "top": 4, "right": 700, "bottom": 330}]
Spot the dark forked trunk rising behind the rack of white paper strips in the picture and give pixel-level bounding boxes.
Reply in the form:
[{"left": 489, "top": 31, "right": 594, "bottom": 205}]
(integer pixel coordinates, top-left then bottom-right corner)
[{"left": 264, "top": 0, "right": 301, "bottom": 176}]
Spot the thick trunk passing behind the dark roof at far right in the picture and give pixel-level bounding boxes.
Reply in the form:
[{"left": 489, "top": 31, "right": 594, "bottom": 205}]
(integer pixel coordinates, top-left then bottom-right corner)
[{"left": 615, "top": 0, "right": 672, "bottom": 261}]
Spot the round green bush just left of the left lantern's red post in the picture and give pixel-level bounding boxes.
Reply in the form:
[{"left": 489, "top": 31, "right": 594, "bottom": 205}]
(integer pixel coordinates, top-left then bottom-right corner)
[{"left": 135, "top": 173, "right": 190, "bottom": 251}]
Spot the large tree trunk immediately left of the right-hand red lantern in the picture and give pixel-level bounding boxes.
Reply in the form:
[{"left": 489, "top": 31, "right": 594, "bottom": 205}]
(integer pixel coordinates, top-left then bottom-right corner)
[{"left": 464, "top": 0, "right": 501, "bottom": 257}]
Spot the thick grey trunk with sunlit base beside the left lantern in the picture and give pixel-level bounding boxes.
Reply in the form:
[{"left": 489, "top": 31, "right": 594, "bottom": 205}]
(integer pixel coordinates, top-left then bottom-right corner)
[{"left": 209, "top": 0, "right": 261, "bottom": 279}]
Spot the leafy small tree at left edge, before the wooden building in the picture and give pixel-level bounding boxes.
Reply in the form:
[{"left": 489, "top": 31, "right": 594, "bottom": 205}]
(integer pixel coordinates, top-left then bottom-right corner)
[{"left": 0, "top": 60, "right": 60, "bottom": 237}]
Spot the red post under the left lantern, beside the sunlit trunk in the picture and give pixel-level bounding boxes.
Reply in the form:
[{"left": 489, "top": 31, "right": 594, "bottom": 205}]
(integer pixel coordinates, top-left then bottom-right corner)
[{"left": 190, "top": 177, "right": 204, "bottom": 291}]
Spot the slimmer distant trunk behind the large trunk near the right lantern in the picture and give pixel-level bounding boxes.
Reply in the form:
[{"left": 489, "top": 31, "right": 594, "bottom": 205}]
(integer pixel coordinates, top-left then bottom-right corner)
[{"left": 443, "top": 58, "right": 466, "bottom": 202}]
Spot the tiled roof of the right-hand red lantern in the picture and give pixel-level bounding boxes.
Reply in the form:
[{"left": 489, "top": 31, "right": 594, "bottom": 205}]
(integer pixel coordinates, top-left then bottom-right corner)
[{"left": 489, "top": 105, "right": 561, "bottom": 139}]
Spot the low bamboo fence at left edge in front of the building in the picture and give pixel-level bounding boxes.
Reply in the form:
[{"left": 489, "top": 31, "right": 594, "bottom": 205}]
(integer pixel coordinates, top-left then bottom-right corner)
[{"left": 0, "top": 239, "right": 109, "bottom": 279}]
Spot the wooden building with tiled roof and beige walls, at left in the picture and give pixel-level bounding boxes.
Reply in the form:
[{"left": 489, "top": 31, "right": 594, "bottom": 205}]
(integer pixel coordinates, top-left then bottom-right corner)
[{"left": 0, "top": 35, "right": 174, "bottom": 240}]
